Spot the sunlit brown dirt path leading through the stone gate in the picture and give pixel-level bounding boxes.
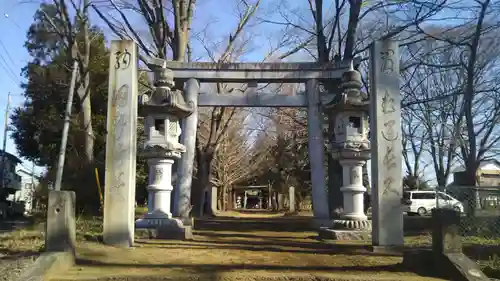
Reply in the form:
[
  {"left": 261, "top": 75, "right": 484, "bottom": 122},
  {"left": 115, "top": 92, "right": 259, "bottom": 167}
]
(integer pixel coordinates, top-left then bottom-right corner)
[{"left": 47, "top": 213, "right": 446, "bottom": 281}]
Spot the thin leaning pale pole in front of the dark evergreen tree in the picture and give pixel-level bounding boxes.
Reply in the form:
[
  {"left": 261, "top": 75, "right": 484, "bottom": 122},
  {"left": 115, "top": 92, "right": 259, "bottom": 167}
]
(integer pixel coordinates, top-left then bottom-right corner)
[{"left": 54, "top": 60, "right": 78, "bottom": 190}]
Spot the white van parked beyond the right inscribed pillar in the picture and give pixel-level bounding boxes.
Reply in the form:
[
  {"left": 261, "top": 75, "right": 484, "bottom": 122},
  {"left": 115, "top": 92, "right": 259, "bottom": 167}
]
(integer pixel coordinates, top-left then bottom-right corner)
[{"left": 402, "top": 190, "right": 464, "bottom": 216}]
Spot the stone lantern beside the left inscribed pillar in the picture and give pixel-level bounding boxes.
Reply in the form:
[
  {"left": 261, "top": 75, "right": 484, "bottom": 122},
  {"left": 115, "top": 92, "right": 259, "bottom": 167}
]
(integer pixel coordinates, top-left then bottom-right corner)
[{"left": 136, "top": 59, "right": 194, "bottom": 236}]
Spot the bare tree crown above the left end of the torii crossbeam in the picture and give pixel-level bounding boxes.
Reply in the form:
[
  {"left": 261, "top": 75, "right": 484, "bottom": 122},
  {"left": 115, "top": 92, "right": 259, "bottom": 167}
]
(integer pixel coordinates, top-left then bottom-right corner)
[{"left": 92, "top": 0, "right": 196, "bottom": 61}]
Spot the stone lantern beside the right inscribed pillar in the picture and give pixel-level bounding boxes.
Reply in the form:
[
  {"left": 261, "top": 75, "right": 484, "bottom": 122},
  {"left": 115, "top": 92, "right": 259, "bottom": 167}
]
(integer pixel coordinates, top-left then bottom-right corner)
[{"left": 325, "top": 62, "right": 371, "bottom": 239}]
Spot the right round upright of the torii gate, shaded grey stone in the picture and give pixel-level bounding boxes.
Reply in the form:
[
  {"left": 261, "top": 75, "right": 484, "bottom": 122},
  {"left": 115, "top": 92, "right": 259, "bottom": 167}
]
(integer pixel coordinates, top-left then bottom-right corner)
[{"left": 306, "top": 79, "right": 330, "bottom": 226}]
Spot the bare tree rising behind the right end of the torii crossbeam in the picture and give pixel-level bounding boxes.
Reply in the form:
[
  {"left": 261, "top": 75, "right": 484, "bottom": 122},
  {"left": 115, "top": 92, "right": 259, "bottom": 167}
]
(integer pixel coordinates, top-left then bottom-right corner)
[{"left": 262, "top": 0, "right": 446, "bottom": 216}]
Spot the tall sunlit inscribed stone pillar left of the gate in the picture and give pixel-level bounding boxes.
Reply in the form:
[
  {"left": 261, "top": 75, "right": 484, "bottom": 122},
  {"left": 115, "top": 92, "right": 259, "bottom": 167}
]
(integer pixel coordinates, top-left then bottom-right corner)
[{"left": 103, "top": 40, "right": 138, "bottom": 247}]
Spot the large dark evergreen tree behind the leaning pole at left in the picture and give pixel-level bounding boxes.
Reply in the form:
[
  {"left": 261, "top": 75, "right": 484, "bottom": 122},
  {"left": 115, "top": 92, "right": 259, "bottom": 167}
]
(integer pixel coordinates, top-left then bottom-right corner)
[{"left": 11, "top": 4, "right": 145, "bottom": 213}]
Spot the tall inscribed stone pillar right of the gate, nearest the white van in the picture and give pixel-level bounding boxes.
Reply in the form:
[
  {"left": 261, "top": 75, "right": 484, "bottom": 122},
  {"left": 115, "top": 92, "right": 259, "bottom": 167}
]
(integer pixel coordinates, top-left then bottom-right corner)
[{"left": 370, "top": 40, "right": 404, "bottom": 246}]
